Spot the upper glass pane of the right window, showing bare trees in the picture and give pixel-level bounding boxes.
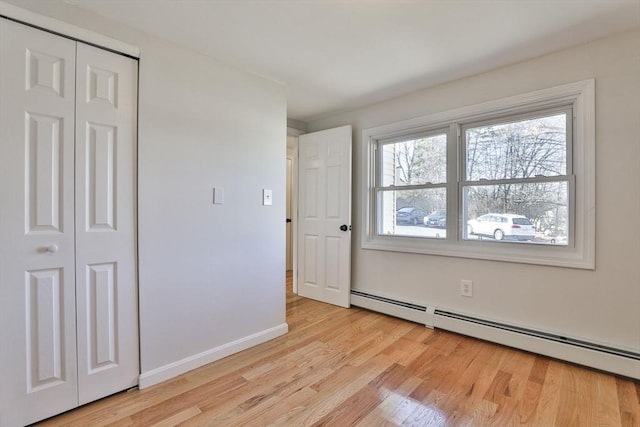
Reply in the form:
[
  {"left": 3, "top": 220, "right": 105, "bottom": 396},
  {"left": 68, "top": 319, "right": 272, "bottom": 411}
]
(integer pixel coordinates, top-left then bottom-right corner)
[{"left": 465, "top": 113, "right": 567, "bottom": 181}]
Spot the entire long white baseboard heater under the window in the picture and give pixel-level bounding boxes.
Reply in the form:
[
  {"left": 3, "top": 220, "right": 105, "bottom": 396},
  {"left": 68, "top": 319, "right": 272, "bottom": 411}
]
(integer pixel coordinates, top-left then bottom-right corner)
[{"left": 351, "top": 290, "right": 640, "bottom": 379}]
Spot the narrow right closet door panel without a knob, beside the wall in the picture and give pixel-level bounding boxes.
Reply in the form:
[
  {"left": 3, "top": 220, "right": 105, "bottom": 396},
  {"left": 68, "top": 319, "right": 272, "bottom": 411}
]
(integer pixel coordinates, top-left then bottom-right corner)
[{"left": 76, "top": 43, "right": 139, "bottom": 404}]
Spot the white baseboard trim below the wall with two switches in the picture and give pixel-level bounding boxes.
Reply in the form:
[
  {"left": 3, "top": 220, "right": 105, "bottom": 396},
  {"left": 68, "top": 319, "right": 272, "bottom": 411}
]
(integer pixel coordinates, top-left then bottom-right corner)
[{"left": 138, "top": 323, "right": 289, "bottom": 389}]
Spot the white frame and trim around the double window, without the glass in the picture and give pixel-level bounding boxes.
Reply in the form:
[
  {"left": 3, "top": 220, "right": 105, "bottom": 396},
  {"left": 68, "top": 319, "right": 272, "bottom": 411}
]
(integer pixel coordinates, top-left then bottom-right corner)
[{"left": 361, "top": 79, "right": 596, "bottom": 269}]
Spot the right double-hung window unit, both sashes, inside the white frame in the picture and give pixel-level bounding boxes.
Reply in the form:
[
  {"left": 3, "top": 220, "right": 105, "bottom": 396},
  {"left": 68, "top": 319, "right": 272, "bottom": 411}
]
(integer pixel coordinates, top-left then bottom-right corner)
[{"left": 461, "top": 106, "right": 573, "bottom": 245}]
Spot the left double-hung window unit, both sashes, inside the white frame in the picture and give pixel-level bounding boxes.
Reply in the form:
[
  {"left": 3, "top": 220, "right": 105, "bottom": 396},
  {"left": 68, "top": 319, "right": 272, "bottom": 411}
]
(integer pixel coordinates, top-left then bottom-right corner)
[{"left": 375, "top": 131, "right": 447, "bottom": 239}]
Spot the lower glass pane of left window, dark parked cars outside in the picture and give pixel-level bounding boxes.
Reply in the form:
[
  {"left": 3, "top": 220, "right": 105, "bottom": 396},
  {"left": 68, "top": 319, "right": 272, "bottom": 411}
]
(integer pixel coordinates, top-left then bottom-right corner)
[{"left": 378, "top": 188, "right": 447, "bottom": 239}]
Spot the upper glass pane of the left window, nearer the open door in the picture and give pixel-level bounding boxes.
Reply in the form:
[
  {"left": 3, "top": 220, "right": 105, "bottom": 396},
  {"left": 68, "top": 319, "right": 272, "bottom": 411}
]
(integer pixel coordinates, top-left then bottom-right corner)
[{"left": 381, "top": 134, "right": 447, "bottom": 187}]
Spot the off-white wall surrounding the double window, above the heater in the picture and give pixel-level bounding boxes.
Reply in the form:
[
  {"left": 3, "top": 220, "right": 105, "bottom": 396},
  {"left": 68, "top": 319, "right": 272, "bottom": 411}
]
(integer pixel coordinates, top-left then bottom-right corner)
[{"left": 308, "top": 31, "right": 640, "bottom": 351}]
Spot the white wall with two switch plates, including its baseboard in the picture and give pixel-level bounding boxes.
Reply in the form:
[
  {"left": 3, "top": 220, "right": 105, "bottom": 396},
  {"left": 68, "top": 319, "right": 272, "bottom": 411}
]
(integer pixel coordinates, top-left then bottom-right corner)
[{"left": 9, "top": 0, "right": 287, "bottom": 385}]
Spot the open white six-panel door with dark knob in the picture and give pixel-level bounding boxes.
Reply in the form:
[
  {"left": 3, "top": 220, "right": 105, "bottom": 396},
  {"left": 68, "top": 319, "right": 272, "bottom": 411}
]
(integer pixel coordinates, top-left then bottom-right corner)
[{"left": 297, "top": 126, "right": 351, "bottom": 307}]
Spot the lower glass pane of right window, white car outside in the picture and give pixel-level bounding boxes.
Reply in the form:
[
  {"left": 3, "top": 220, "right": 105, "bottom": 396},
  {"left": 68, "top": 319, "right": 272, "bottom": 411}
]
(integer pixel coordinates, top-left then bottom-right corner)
[{"left": 463, "top": 181, "right": 569, "bottom": 245}]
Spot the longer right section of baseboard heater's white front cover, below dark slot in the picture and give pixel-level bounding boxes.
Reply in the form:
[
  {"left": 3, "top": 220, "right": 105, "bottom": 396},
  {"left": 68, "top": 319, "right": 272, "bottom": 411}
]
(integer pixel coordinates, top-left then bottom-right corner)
[{"left": 434, "top": 313, "right": 640, "bottom": 379}]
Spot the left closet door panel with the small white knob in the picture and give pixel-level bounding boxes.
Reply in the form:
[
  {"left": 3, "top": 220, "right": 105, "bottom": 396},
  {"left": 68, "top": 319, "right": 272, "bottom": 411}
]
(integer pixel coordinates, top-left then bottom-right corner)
[{"left": 0, "top": 18, "right": 78, "bottom": 426}]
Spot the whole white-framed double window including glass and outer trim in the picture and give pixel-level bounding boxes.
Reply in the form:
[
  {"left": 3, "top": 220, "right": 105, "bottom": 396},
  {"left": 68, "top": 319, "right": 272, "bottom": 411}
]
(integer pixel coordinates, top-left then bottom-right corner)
[{"left": 361, "top": 80, "right": 595, "bottom": 268}]
